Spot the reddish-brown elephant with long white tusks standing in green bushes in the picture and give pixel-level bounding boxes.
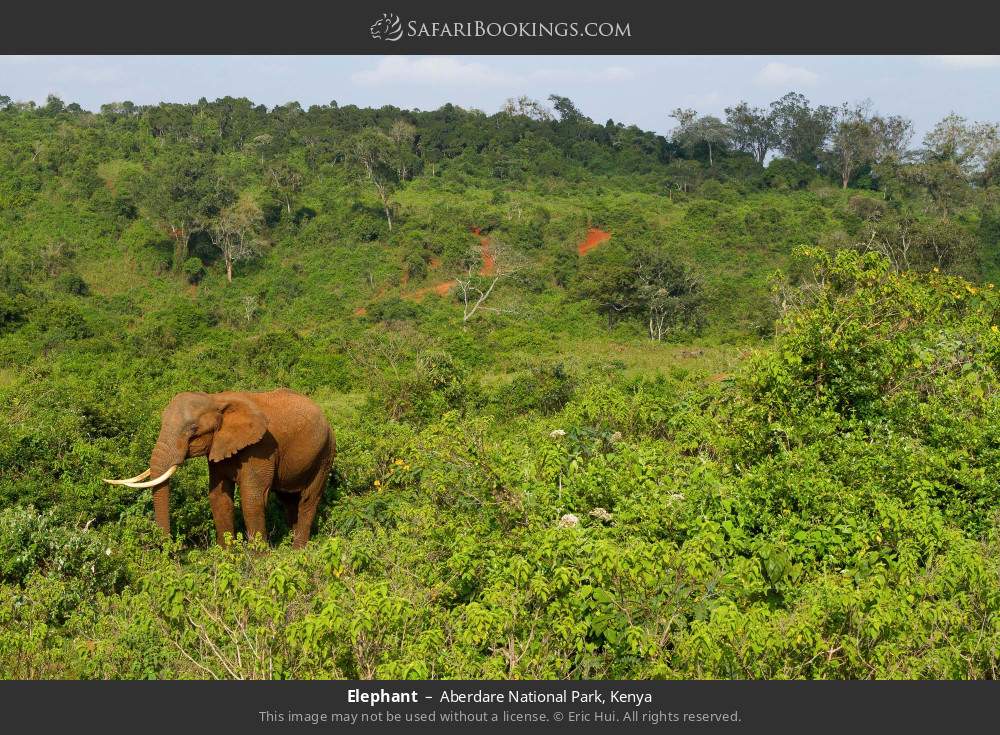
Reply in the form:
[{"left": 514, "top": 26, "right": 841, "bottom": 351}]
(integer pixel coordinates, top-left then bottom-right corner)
[{"left": 105, "top": 388, "right": 337, "bottom": 549}]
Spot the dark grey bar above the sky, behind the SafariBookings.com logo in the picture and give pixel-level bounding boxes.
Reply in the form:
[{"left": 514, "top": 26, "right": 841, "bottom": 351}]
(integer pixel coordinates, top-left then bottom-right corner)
[{"left": 0, "top": 0, "right": 1000, "bottom": 54}]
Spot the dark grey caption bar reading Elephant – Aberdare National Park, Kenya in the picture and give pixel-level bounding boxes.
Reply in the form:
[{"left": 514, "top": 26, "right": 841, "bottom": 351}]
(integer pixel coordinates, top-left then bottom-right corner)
[{"left": 0, "top": 681, "right": 1000, "bottom": 735}]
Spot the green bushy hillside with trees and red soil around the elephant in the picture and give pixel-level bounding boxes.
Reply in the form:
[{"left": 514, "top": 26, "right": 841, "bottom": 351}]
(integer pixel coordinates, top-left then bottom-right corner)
[{"left": 0, "top": 94, "right": 1000, "bottom": 678}]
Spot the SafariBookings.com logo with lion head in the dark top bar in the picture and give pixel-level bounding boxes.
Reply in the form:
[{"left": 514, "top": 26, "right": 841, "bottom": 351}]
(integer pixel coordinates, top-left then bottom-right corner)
[{"left": 369, "top": 13, "right": 632, "bottom": 41}]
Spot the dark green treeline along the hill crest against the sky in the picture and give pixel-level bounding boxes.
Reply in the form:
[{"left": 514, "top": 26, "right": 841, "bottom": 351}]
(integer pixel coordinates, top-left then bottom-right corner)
[{"left": 0, "top": 92, "right": 1000, "bottom": 197}]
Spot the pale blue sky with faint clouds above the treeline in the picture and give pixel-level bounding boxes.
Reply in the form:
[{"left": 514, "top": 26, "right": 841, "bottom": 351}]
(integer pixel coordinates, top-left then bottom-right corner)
[{"left": 0, "top": 56, "right": 1000, "bottom": 140}]
